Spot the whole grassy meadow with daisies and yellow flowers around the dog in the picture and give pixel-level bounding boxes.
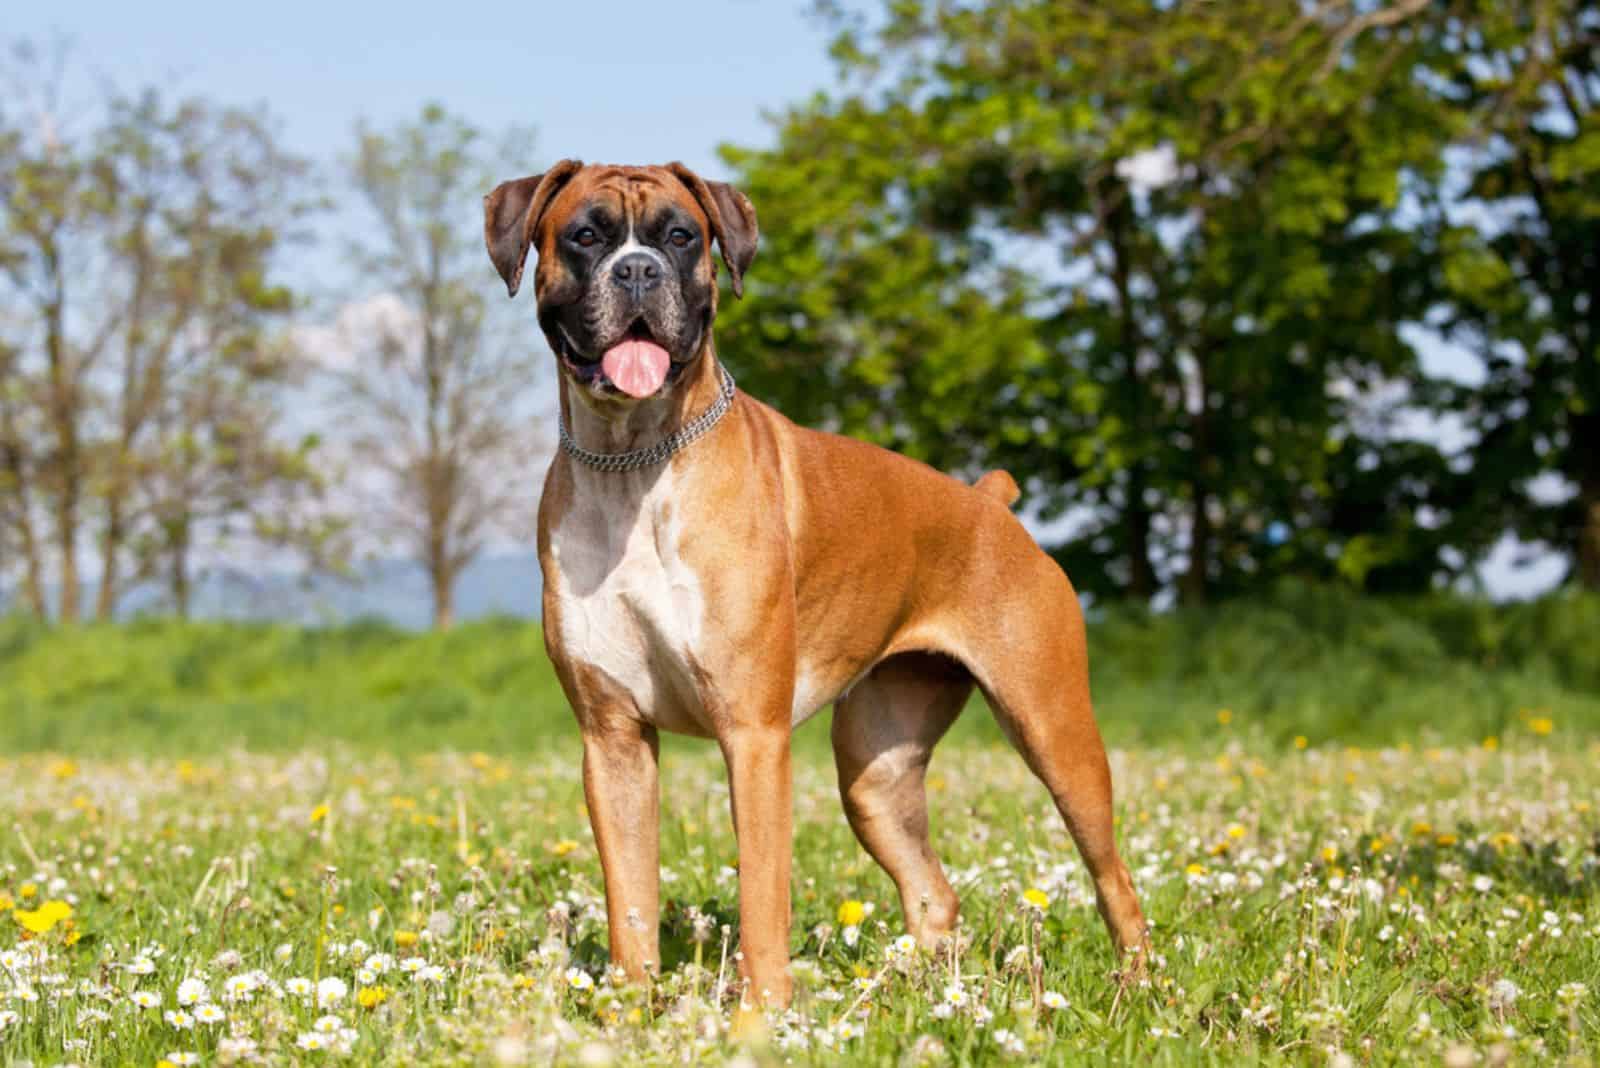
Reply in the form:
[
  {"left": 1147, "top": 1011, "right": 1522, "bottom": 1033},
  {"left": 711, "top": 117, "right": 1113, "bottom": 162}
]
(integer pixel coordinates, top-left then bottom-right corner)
[{"left": 0, "top": 588, "right": 1600, "bottom": 1065}]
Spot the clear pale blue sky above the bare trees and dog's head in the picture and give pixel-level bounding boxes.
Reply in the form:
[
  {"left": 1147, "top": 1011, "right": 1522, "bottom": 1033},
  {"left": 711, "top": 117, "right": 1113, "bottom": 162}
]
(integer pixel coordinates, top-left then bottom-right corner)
[{"left": 15, "top": 0, "right": 832, "bottom": 176}]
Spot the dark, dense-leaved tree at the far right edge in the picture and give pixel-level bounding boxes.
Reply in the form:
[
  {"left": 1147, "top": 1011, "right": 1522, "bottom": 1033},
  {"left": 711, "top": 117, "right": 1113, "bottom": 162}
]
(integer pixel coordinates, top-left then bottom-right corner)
[{"left": 1426, "top": 0, "right": 1600, "bottom": 590}]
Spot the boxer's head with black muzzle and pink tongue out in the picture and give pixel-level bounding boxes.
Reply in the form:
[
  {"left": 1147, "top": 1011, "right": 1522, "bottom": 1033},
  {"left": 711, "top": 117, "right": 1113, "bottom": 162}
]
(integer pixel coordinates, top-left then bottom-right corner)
[{"left": 483, "top": 160, "right": 757, "bottom": 403}]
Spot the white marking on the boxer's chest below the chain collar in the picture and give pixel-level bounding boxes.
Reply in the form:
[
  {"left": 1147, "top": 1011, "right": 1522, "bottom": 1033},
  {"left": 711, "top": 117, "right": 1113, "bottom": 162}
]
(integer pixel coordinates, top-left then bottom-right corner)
[{"left": 550, "top": 468, "right": 706, "bottom": 732}]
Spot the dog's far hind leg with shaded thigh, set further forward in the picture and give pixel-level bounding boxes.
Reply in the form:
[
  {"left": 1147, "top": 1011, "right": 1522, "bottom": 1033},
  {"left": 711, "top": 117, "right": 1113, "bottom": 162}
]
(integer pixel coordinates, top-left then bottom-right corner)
[{"left": 834, "top": 654, "right": 973, "bottom": 948}]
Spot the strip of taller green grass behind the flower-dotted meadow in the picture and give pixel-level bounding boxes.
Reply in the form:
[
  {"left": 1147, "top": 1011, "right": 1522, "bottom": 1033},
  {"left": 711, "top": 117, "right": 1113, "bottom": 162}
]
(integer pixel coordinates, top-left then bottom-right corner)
[{"left": 0, "top": 584, "right": 1600, "bottom": 755}]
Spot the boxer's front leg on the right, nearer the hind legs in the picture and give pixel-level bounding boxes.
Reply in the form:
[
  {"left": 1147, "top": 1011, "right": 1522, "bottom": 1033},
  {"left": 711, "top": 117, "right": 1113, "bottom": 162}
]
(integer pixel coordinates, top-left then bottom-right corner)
[{"left": 722, "top": 718, "right": 794, "bottom": 1007}]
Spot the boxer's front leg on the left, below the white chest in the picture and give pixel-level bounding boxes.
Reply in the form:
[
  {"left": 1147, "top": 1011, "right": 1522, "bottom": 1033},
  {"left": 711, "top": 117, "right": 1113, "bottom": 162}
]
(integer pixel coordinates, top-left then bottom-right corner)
[{"left": 584, "top": 716, "right": 661, "bottom": 980}]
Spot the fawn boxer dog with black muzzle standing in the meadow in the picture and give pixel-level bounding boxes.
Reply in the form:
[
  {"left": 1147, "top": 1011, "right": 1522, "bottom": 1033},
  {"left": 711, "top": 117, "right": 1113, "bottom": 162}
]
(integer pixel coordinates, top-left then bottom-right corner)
[{"left": 483, "top": 160, "right": 1146, "bottom": 1006}]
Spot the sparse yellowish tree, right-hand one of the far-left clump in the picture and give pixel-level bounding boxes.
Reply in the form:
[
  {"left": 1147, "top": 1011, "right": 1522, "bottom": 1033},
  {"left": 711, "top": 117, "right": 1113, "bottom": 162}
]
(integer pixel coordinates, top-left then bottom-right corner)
[{"left": 96, "top": 90, "right": 328, "bottom": 619}]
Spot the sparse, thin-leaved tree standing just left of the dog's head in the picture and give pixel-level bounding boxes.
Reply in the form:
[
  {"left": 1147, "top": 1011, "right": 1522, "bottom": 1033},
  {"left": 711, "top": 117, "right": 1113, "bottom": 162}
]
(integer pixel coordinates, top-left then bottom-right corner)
[{"left": 341, "top": 106, "right": 538, "bottom": 627}]
